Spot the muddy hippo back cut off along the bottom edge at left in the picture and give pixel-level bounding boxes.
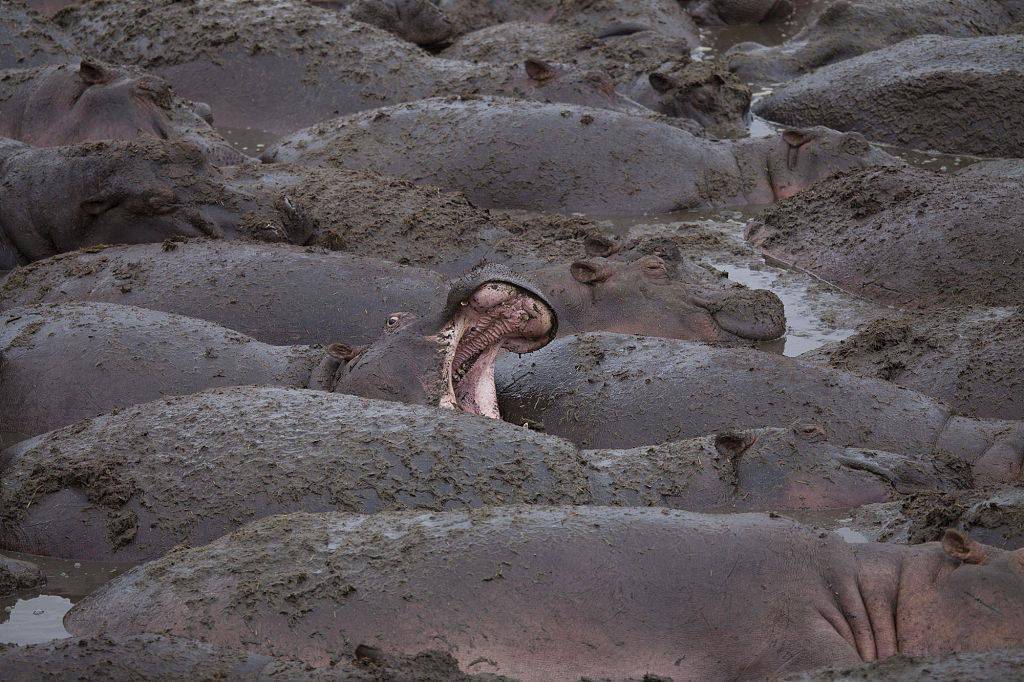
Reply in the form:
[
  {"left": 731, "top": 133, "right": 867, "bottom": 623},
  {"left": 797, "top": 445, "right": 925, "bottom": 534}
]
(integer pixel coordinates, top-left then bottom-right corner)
[{"left": 0, "top": 635, "right": 499, "bottom": 682}]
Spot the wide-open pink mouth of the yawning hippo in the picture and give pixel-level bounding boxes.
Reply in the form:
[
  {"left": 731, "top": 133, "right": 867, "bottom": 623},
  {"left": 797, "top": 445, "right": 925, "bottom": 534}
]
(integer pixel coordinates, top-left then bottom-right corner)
[{"left": 438, "top": 282, "right": 555, "bottom": 419}]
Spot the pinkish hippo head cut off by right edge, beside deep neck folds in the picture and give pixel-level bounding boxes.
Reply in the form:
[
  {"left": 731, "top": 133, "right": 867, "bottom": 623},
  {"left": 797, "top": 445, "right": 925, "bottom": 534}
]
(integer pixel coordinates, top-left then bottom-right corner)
[{"left": 896, "top": 529, "right": 1024, "bottom": 655}]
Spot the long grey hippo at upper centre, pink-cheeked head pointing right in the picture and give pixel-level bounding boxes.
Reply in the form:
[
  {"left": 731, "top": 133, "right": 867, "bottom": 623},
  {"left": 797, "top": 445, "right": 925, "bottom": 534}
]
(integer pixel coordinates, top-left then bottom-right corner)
[{"left": 263, "top": 97, "right": 900, "bottom": 216}]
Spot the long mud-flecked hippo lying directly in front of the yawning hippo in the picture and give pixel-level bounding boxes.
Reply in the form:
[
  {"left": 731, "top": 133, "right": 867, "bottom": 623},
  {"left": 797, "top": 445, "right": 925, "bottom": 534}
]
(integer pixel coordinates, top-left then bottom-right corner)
[{"left": 0, "top": 387, "right": 967, "bottom": 561}]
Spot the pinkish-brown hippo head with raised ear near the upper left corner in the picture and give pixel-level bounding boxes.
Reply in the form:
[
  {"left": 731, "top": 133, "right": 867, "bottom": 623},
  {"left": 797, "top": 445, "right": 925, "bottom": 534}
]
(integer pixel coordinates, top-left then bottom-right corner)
[{"left": 22, "top": 58, "right": 204, "bottom": 146}]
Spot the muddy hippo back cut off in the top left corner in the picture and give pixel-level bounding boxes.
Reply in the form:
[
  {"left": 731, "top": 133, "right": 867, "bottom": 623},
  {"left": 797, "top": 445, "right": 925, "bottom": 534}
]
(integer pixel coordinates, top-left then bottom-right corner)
[{"left": 0, "top": 0, "right": 77, "bottom": 69}]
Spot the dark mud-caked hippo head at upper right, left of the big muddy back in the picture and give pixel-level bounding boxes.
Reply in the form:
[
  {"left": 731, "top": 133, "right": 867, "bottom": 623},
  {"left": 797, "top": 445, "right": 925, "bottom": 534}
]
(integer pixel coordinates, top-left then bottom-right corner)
[{"left": 644, "top": 61, "right": 751, "bottom": 137}]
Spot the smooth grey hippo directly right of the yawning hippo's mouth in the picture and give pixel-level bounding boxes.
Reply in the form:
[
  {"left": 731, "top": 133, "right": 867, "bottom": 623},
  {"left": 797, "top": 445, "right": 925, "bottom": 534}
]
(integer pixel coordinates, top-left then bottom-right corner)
[{"left": 496, "top": 333, "right": 1024, "bottom": 481}]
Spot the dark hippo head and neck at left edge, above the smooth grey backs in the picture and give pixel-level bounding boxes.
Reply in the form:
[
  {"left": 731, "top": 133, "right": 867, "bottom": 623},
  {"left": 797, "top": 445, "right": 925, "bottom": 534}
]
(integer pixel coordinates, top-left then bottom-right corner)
[{"left": 0, "top": 138, "right": 272, "bottom": 270}]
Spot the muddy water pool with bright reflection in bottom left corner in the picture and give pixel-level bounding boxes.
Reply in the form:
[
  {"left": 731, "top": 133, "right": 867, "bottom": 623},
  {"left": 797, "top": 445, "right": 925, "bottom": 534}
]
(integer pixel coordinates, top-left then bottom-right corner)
[{"left": 0, "top": 552, "right": 135, "bottom": 644}]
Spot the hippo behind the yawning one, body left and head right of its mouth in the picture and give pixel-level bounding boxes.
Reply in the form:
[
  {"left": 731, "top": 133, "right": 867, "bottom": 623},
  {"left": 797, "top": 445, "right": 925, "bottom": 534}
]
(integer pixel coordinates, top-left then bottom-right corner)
[{"left": 0, "top": 239, "right": 785, "bottom": 345}]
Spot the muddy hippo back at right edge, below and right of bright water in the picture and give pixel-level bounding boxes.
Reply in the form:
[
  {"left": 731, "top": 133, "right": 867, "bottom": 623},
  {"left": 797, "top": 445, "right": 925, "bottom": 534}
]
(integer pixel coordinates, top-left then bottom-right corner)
[{"left": 802, "top": 306, "right": 1024, "bottom": 420}]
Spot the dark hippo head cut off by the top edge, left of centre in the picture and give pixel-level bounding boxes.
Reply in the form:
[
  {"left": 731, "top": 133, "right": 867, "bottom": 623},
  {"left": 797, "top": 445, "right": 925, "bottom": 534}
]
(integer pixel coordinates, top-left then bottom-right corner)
[{"left": 313, "top": 0, "right": 453, "bottom": 46}]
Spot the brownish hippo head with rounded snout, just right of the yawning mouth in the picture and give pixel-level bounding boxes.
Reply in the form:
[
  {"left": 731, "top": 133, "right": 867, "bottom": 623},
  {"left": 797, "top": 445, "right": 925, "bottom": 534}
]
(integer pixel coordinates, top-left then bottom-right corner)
[{"left": 530, "top": 249, "right": 785, "bottom": 341}]
